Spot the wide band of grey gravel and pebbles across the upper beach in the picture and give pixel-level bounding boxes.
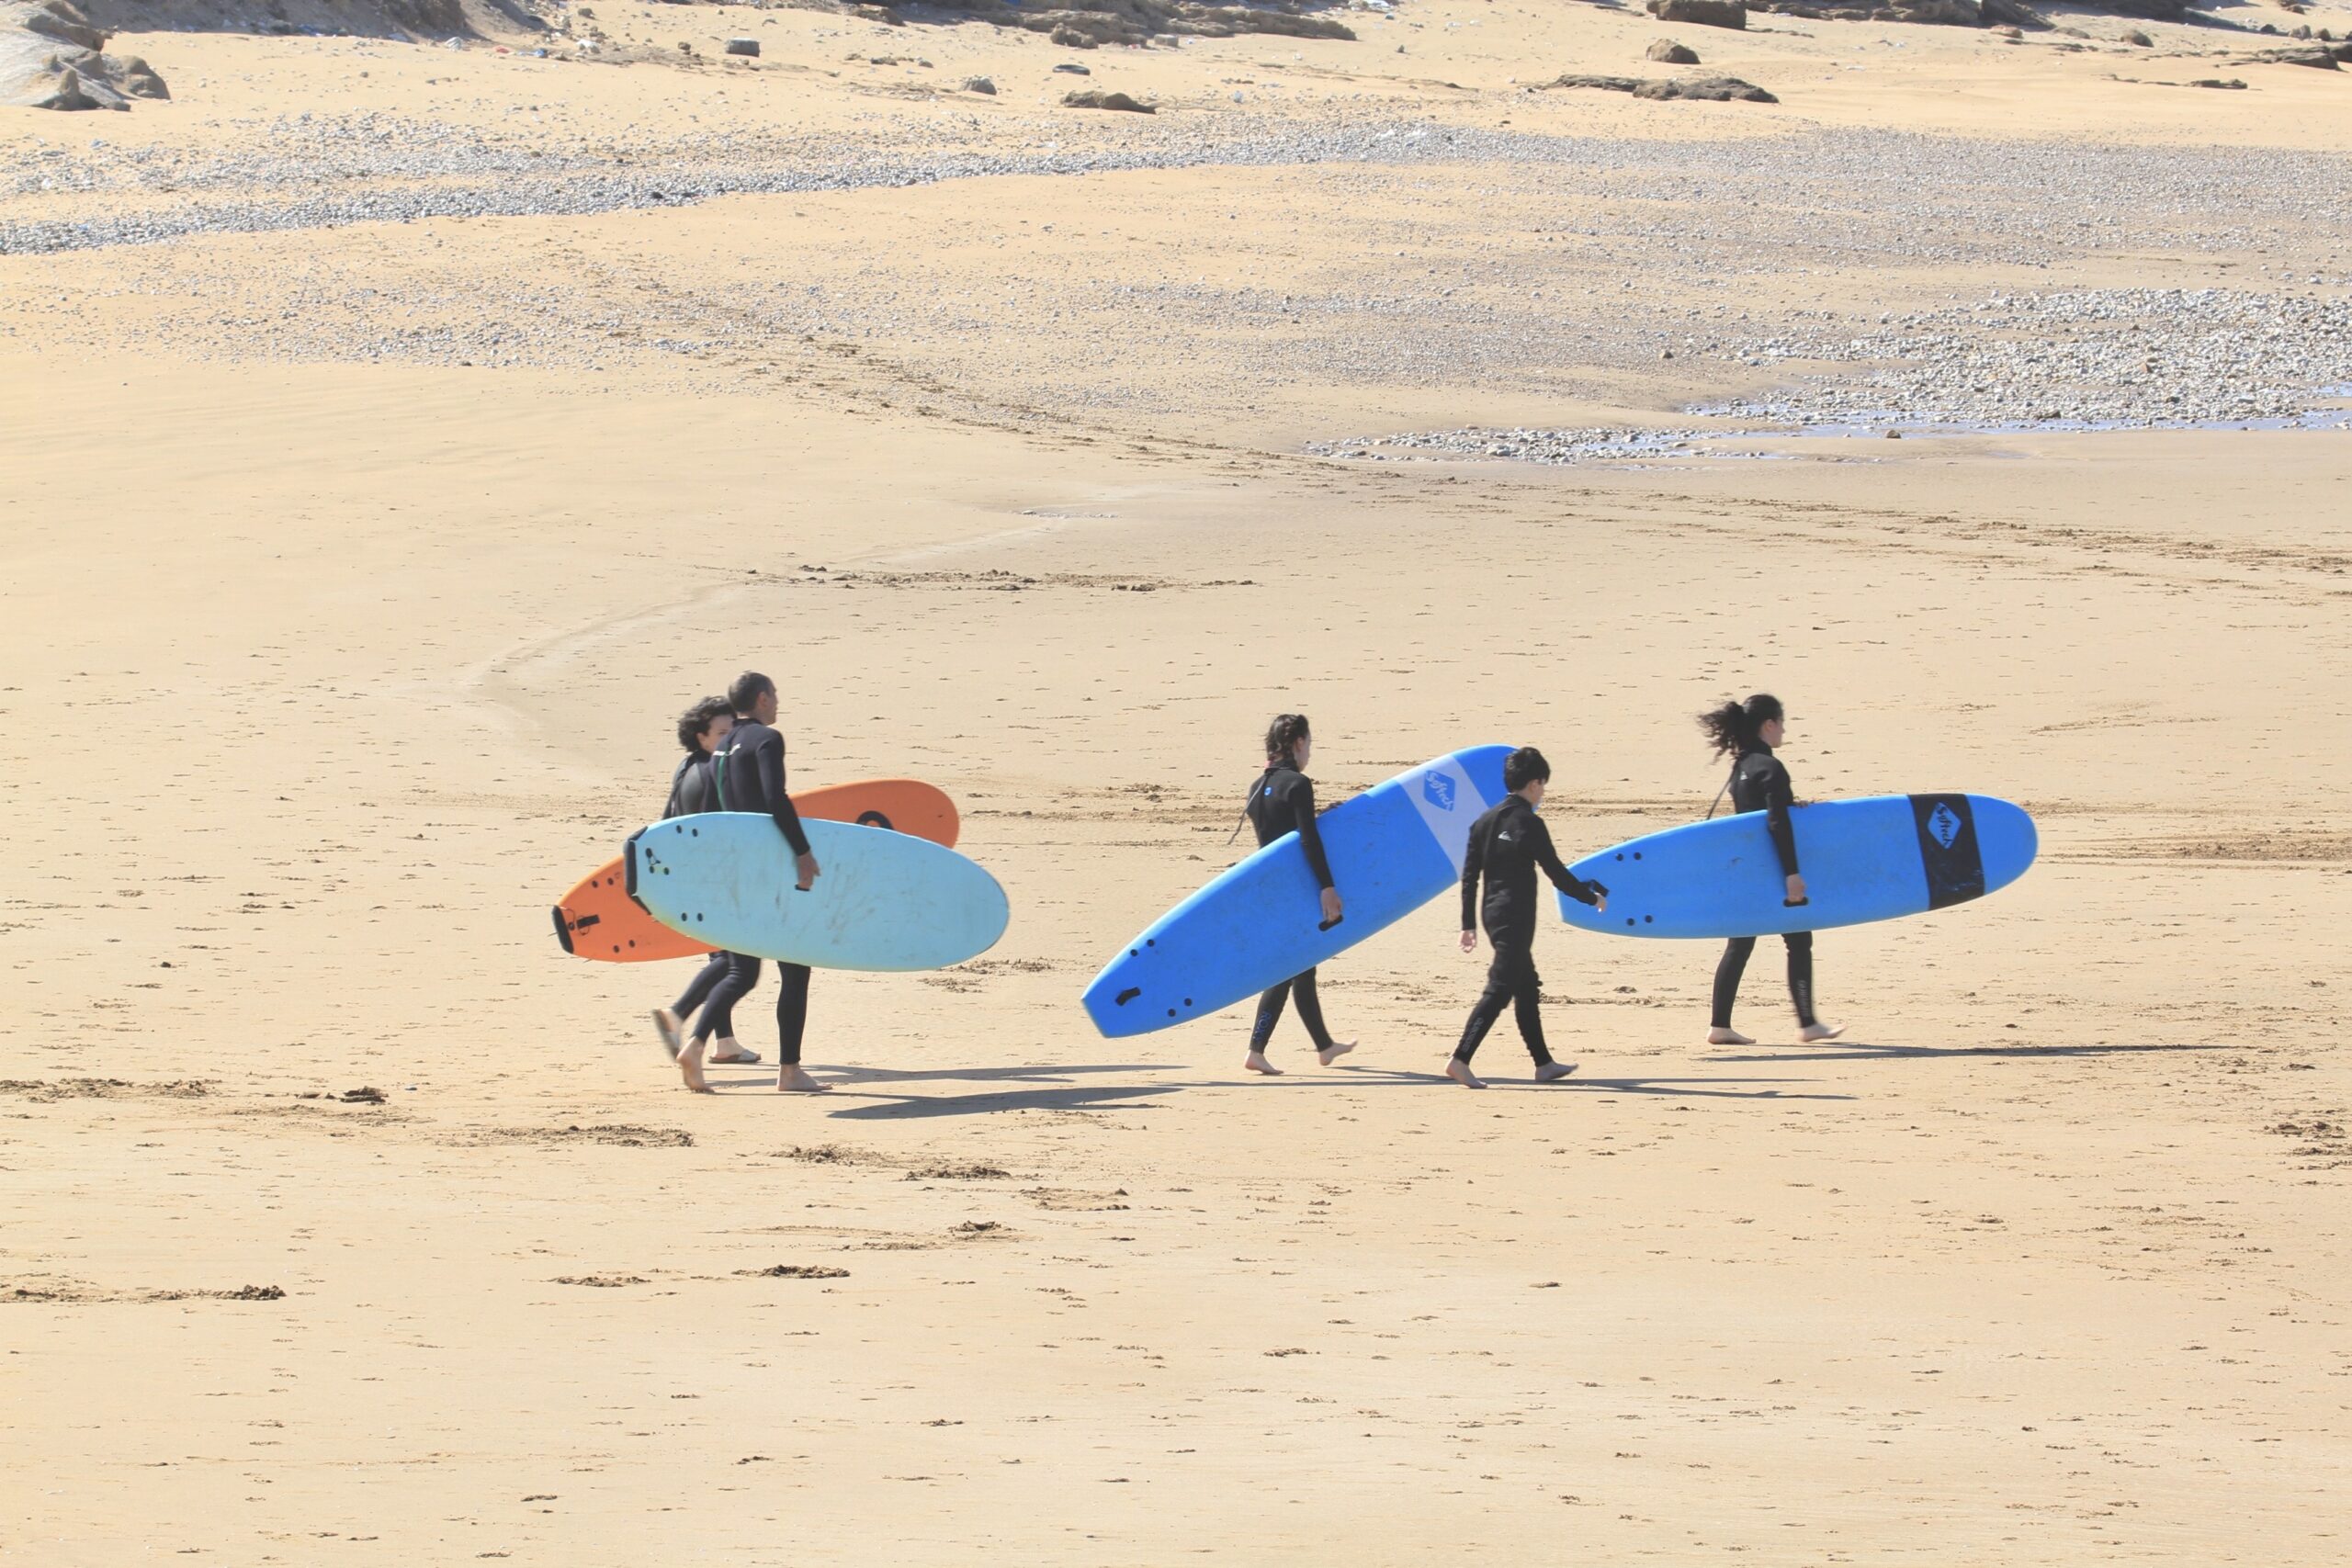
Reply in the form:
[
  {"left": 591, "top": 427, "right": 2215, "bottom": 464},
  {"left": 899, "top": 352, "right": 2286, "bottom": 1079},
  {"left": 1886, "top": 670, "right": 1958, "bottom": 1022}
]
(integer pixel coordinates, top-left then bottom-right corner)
[{"left": 0, "top": 106, "right": 2352, "bottom": 442}]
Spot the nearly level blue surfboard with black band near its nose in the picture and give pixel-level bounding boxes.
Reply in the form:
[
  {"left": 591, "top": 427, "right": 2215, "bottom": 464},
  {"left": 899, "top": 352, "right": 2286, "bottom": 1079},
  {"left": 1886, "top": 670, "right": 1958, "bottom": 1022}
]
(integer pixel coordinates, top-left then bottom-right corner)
[{"left": 1559, "top": 795, "right": 2040, "bottom": 936}]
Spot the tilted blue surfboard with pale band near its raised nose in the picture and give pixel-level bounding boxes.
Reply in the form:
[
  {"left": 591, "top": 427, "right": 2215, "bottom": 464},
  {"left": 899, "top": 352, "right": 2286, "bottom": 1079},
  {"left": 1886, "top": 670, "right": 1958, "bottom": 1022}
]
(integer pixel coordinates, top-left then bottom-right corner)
[{"left": 1084, "top": 745, "right": 1510, "bottom": 1039}]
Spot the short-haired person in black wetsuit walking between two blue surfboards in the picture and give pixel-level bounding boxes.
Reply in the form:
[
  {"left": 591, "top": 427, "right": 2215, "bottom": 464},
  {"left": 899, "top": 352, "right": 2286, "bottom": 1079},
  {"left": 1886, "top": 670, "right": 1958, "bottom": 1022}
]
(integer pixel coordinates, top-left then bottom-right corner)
[{"left": 1446, "top": 745, "right": 1609, "bottom": 1089}]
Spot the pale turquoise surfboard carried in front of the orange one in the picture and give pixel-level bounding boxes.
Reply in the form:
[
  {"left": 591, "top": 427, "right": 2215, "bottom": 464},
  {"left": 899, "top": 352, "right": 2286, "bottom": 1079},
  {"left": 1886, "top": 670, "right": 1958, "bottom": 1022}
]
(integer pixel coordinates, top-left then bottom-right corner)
[{"left": 626, "top": 811, "right": 1009, "bottom": 968}]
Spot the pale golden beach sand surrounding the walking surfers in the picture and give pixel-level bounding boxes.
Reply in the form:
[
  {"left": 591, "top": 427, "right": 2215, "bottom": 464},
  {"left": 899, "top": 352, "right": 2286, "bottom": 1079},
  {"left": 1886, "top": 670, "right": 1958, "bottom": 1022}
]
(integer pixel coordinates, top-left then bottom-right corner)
[{"left": 0, "top": 0, "right": 2352, "bottom": 1568}]
